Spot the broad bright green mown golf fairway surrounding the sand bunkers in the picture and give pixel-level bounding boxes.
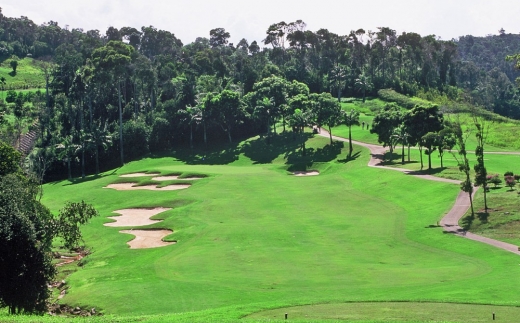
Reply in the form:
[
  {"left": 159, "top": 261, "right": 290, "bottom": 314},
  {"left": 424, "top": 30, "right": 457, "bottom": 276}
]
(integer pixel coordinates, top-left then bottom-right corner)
[{"left": 26, "top": 133, "right": 520, "bottom": 318}]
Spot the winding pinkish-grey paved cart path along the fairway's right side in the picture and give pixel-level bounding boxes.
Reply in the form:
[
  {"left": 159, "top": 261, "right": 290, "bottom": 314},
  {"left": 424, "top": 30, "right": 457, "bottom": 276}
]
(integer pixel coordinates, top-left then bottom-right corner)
[{"left": 319, "top": 129, "right": 520, "bottom": 255}]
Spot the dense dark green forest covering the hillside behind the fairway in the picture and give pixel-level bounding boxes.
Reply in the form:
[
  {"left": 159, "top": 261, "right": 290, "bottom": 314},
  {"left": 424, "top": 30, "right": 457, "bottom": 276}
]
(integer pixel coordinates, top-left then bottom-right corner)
[{"left": 0, "top": 9, "right": 520, "bottom": 180}]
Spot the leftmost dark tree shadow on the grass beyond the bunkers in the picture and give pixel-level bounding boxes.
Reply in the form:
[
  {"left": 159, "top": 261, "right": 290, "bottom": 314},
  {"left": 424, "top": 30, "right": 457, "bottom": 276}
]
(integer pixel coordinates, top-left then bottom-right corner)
[{"left": 172, "top": 143, "right": 240, "bottom": 165}]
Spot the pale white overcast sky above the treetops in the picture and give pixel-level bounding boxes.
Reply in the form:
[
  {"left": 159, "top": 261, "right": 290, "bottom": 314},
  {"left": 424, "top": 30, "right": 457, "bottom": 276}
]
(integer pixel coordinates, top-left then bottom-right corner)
[{"left": 0, "top": 0, "right": 520, "bottom": 44}]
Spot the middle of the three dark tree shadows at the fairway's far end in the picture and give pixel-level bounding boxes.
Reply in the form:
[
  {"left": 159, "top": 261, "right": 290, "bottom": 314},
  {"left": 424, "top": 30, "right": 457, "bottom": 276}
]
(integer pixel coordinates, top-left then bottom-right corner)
[{"left": 242, "top": 132, "right": 306, "bottom": 164}]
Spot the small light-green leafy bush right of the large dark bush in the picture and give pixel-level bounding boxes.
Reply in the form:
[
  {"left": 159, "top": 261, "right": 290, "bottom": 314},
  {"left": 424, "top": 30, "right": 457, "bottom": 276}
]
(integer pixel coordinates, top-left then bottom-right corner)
[{"left": 56, "top": 201, "right": 99, "bottom": 250}]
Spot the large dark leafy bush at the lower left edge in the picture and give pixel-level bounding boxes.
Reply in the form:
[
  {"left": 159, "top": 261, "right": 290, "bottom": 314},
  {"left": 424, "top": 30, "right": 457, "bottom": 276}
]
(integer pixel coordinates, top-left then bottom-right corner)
[{"left": 0, "top": 174, "right": 55, "bottom": 314}]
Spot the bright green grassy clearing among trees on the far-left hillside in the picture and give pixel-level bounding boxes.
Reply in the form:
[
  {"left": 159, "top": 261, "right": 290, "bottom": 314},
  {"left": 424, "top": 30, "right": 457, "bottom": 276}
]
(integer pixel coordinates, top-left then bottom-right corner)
[{"left": 0, "top": 57, "right": 45, "bottom": 90}]
